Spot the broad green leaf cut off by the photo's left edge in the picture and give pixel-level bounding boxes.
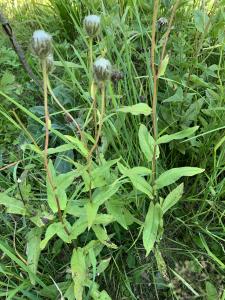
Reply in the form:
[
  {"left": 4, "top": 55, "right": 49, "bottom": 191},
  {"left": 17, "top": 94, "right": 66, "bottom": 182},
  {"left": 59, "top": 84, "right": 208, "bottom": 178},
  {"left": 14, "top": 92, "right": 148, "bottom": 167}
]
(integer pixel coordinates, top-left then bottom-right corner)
[{"left": 0, "top": 193, "right": 26, "bottom": 215}]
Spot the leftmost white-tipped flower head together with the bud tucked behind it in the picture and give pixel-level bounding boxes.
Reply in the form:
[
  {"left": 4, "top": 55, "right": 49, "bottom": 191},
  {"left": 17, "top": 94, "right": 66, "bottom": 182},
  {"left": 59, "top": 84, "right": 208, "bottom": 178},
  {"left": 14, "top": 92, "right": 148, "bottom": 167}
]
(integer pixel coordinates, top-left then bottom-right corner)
[{"left": 32, "top": 30, "right": 54, "bottom": 73}]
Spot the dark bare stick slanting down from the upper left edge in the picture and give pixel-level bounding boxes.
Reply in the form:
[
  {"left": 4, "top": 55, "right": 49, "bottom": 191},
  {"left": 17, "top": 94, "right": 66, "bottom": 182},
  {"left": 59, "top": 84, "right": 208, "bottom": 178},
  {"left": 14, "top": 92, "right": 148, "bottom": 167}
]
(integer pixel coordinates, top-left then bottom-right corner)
[{"left": 0, "top": 12, "right": 42, "bottom": 91}]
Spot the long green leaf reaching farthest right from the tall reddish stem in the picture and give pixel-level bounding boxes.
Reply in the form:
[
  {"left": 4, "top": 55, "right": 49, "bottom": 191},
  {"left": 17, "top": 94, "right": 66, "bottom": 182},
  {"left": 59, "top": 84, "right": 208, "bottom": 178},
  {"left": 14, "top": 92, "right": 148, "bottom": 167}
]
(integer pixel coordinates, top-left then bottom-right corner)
[{"left": 156, "top": 167, "right": 204, "bottom": 189}]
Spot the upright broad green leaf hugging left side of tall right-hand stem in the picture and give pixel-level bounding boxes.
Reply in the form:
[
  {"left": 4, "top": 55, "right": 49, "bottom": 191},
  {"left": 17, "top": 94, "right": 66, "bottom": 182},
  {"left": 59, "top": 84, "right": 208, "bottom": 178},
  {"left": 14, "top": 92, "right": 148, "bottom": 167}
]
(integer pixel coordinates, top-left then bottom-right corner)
[{"left": 138, "top": 124, "right": 159, "bottom": 162}]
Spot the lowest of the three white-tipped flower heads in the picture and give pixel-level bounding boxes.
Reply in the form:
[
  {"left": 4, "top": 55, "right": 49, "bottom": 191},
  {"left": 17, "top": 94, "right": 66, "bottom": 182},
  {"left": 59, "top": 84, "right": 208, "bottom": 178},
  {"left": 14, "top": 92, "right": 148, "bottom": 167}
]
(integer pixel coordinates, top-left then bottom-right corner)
[{"left": 94, "top": 58, "right": 112, "bottom": 81}]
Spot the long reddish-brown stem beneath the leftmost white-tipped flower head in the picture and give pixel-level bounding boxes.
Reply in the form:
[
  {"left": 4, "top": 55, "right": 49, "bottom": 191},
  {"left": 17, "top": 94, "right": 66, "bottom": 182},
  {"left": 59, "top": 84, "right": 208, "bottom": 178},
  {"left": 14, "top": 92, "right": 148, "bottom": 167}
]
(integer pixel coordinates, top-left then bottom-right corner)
[{"left": 42, "top": 59, "right": 69, "bottom": 235}]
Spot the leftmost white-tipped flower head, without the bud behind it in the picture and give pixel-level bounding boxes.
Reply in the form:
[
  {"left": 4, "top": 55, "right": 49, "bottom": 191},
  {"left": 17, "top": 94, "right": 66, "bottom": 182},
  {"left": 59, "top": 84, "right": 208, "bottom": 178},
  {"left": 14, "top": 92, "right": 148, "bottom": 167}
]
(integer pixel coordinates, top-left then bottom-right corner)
[{"left": 32, "top": 30, "right": 52, "bottom": 59}]
